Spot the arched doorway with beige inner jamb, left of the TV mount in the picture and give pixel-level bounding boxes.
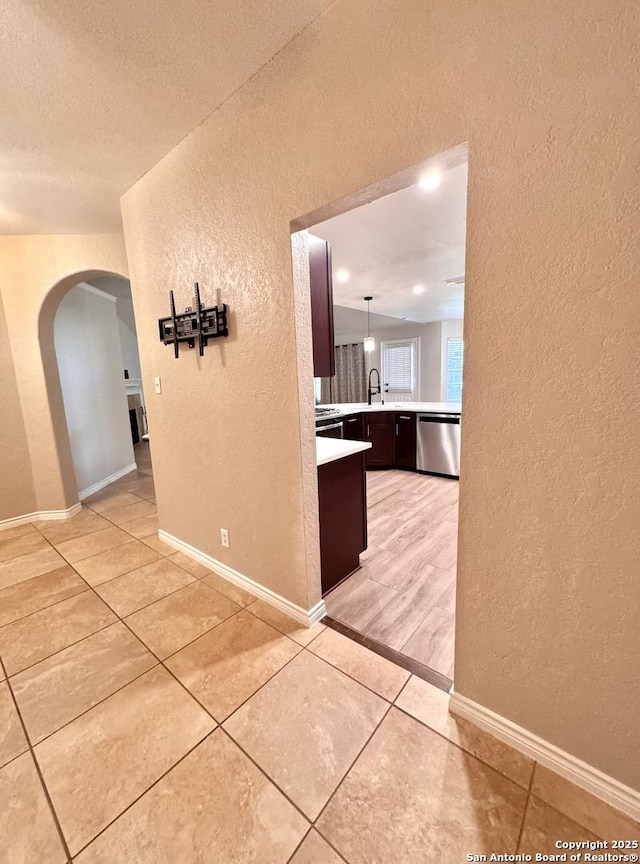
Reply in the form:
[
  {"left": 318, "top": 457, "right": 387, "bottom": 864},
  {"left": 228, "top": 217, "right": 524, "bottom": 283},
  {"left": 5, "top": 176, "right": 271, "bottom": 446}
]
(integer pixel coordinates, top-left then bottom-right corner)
[{"left": 38, "top": 270, "right": 149, "bottom": 505}]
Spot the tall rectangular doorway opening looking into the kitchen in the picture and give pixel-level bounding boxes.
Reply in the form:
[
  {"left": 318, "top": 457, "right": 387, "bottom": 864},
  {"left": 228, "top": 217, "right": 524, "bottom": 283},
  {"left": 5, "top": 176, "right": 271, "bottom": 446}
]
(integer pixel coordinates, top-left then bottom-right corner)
[{"left": 292, "top": 145, "right": 468, "bottom": 690}]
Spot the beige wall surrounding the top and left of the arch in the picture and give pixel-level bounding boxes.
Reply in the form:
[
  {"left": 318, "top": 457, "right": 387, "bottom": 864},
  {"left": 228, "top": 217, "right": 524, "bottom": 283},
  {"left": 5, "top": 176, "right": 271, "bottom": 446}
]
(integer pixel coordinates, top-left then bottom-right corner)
[{"left": 0, "top": 234, "right": 127, "bottom": 517}]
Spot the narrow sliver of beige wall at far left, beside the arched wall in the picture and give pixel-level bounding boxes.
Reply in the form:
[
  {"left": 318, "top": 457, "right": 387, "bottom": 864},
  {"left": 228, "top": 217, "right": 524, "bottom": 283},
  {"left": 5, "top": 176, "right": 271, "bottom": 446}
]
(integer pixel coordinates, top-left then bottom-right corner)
[{"left": 0, "top": 295, "right": 36, "bottom": 520}]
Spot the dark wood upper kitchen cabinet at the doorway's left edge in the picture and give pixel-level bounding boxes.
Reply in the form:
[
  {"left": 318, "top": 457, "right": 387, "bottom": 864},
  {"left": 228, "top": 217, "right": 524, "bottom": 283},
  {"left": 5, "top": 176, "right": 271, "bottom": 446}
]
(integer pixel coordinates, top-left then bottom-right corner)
[{"left": 308, "top": 234, "right": 336, "bottom": 378}]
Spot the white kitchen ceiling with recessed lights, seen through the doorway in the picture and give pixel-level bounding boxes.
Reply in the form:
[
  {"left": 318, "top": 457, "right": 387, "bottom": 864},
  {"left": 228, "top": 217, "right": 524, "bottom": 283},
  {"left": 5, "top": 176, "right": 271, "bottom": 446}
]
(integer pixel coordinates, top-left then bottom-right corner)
[{"left": 309, "top": 159, "right": 467, "bottom": 322}]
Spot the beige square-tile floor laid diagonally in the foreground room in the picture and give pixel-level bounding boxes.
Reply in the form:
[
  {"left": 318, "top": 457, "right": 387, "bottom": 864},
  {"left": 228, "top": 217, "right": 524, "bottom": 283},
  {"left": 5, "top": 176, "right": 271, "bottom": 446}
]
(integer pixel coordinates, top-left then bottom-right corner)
[{"left": 0, "top": 448, "right": 640, "bottom": 864}]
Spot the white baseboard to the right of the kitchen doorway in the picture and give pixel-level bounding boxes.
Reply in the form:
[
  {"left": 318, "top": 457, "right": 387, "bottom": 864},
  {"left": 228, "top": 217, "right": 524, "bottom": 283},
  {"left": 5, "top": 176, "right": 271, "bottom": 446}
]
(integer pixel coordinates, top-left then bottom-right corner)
[{"left": 449, "top": 693, "right": 640, "bottom": 821}]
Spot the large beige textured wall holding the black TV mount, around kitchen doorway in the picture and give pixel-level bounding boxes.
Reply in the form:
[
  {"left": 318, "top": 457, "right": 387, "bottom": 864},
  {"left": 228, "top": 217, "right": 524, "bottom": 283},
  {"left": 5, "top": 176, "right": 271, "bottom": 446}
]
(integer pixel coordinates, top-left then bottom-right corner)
[{"left": 123, "top": 0, "right": 640, "bottom": 787}]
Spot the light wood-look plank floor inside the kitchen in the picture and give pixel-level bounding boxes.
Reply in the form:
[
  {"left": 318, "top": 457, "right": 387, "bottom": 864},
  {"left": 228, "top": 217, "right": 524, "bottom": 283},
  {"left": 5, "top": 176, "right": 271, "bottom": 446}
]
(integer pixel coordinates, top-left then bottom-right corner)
[{"left": 325, "top": 471, "right": 458, "bottom": 678}]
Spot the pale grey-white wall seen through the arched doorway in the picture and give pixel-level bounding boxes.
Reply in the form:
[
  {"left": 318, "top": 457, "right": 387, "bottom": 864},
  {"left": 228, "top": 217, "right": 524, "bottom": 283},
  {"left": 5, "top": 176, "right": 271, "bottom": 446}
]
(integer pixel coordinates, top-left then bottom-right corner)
[{"left": 54, "top": 284, "right": 135, "bottom": 495}]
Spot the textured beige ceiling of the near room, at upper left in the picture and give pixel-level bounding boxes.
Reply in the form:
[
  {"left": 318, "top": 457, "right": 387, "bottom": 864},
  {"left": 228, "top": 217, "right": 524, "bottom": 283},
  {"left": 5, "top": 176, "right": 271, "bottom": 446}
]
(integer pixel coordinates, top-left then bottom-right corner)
[{"left": 0, "top": 0, "right": 331, "bottom": 234}]
